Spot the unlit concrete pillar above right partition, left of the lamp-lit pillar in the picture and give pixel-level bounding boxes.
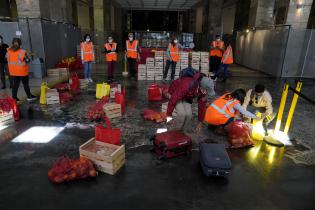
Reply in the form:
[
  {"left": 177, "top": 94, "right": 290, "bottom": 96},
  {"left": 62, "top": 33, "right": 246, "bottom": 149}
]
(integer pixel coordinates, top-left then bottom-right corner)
[{"left": 248, "top": 0, "right": 275, "bottom": 27}]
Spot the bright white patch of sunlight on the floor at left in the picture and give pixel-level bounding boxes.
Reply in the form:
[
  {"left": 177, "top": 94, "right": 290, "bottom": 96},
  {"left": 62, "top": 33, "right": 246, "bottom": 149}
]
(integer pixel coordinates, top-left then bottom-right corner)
[{"left": 12, "top": 126, "right": 64, "bottom": 143}]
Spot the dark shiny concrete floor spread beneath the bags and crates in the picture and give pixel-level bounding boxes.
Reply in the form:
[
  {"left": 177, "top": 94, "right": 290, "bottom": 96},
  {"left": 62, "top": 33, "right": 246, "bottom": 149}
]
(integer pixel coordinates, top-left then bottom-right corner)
[{"left": 0, "top": 65, "right": 315, "bottom": 210}]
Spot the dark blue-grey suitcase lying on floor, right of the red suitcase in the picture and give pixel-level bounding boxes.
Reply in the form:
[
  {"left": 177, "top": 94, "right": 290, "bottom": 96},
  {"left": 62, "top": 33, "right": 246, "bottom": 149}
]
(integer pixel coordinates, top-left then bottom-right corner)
[{"left": 199, "top": 143, "right": 232, "bottom": 177}]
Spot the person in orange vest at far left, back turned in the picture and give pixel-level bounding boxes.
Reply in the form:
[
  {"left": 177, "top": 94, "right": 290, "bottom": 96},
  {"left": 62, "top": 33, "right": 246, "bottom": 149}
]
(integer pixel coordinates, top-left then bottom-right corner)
[{"left": 6, "top": 38, "right": 37, "bottom": 101}]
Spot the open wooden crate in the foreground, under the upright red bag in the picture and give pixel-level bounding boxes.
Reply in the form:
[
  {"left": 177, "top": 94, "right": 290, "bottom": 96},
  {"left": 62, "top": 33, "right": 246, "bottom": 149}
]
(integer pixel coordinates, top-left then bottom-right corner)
[{"left": 79, "top": 138, "right": 125, "bottom": 175}]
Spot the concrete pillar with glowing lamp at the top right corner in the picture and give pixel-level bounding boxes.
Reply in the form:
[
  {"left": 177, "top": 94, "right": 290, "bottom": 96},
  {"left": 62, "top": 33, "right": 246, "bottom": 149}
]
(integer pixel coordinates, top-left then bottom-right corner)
[{"left": 286, "top": 0, "right": 313, "bottom": 29}]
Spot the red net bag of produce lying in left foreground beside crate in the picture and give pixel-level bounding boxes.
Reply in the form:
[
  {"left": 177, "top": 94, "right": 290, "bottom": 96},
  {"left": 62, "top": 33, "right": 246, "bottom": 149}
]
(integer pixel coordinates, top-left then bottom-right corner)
[{"left": 48, "top": 156, "right": 97, "bottom": 184}]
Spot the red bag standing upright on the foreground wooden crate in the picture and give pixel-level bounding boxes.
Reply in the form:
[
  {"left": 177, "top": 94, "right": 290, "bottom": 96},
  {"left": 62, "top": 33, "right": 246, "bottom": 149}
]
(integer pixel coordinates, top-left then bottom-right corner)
[{"left": 95, "top": 118, "right": 120, "bottom": 145}]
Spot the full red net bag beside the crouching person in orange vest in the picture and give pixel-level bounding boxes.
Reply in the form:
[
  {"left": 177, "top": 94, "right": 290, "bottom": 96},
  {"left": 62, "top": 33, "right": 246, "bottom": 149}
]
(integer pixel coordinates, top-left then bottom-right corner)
[{"left": 228, "top": 121, "right": 253, "bottom": 148}]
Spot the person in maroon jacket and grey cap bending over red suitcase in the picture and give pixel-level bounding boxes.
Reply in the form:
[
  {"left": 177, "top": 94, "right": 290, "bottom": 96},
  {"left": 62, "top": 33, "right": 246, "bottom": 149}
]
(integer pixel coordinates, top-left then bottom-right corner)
[{"left": 166, "top": 72, "right": 215, "bottom": 132}]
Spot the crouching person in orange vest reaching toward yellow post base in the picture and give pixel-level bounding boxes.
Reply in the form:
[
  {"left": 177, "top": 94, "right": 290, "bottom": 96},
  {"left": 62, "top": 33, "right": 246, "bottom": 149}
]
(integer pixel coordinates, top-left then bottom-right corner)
[{"left": 204, "top": 89, "right": 257, "bottom": 135}]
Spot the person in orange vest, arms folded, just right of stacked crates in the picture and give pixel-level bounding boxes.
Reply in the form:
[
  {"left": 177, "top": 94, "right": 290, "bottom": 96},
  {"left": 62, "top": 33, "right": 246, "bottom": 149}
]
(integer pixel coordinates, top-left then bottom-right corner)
[{"left": 209, "top": 35, "right": 224, "bottom": 75}]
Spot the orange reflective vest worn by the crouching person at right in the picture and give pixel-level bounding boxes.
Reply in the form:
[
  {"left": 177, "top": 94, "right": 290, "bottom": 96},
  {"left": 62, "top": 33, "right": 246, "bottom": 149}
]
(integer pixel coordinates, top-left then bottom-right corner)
[{"left": 204, "top": 94, "right": 240, "bottom": 125}]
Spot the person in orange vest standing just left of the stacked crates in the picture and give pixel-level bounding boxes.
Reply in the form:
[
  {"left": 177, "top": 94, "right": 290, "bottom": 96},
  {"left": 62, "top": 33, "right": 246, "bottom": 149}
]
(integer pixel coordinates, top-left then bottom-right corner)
[{"left": 126, "top": 33, "right": 140, "bottom": 79}]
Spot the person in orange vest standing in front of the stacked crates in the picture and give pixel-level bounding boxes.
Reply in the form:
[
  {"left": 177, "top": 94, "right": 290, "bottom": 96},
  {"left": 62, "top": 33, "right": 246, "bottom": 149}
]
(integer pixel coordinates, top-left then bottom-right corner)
[{"left": 163, "top": 37, "right": 181, "bottom": 82}]
